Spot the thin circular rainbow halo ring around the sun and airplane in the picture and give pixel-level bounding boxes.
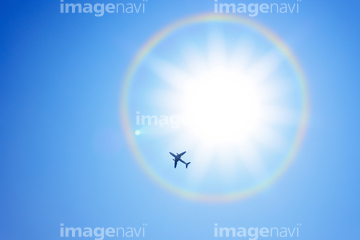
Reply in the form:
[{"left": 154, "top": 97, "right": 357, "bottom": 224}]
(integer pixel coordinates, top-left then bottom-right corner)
[{"left": 120, "top": 14, "right": 309, "bottom": 202}]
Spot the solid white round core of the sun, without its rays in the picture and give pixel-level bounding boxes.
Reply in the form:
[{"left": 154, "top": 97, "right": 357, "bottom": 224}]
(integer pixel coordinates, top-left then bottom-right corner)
[{"left": 179, "top": 64, "right": 266, "bottom": 147}]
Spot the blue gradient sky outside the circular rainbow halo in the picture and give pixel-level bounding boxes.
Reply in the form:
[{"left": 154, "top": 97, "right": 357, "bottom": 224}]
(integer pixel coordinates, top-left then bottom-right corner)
[{"left": 0, "top": 0, "right": 360, "bottom": 240}]
